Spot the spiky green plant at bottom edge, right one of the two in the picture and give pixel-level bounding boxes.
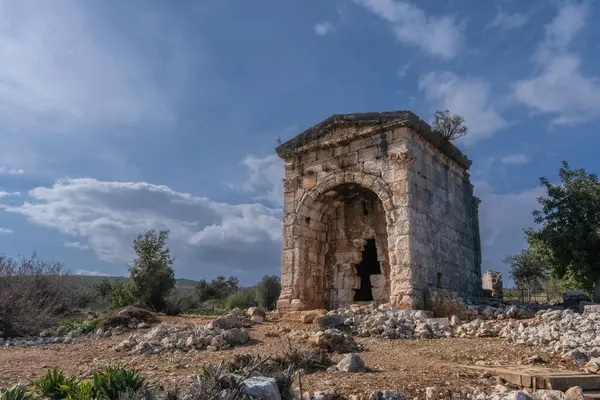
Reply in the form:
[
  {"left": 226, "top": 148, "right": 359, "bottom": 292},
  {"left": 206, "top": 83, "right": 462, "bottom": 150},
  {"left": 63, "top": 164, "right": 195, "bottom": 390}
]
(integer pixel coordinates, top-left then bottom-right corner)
[{"left": 93, "top": 366, "right": 146, "bottom": 400}]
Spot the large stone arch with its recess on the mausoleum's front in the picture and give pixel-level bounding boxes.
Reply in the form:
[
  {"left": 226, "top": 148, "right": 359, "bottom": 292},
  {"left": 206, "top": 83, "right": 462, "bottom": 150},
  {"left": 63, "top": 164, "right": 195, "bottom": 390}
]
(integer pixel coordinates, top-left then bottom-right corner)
[{"left": 292, "top": 172, "right": 395, "bottom": 309}]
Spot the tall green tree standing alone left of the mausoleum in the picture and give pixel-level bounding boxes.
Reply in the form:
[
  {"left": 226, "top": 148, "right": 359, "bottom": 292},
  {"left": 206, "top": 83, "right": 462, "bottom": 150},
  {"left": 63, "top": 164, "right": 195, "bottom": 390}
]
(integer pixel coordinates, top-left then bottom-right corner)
[{"left": 129, "top": 229, "right": 175, "bottom": 311}]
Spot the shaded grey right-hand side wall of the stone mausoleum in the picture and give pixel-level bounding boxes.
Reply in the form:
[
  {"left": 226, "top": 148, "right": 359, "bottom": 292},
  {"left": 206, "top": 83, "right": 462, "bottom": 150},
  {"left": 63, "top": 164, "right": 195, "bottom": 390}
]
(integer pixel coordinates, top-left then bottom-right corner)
[{"left": 406, "top": 135, "right": 481, "bottom": 308}]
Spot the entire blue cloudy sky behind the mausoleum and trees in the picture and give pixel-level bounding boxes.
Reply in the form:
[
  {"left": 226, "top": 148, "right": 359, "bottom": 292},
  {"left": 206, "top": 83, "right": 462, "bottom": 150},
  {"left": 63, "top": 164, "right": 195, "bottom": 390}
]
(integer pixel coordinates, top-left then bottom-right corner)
[{"left": 0, "top": 0, "right": 600, "bottom": 284}]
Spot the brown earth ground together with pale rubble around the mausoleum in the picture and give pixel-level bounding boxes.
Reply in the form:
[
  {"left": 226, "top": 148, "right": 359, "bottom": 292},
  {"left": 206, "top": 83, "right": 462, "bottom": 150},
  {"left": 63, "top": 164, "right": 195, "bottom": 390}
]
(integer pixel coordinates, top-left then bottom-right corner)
[{"left": 0, "top": 307, "right": 600, "bottom": 399}]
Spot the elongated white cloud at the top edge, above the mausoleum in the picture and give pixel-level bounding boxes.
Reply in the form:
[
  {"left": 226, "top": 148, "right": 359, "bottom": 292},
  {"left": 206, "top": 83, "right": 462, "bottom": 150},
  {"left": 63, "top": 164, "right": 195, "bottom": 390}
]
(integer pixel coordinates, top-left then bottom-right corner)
[{"left": 355, "top": 0, "right": 464, "bottom": 59}]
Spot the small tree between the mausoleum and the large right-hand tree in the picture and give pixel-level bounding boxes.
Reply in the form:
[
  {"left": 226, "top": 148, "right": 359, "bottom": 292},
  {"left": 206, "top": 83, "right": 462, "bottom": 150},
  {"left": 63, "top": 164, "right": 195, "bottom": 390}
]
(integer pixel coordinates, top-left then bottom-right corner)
[{"left": 504, "top": 249, "right": 547, "bottom": 299}]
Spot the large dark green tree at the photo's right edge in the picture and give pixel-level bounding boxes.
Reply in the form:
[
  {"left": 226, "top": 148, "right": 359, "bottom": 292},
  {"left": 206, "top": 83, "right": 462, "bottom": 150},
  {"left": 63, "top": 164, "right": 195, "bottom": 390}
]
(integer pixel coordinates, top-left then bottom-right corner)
[{"left": 526, "top": 161, "right": 600, "bottom": 298}]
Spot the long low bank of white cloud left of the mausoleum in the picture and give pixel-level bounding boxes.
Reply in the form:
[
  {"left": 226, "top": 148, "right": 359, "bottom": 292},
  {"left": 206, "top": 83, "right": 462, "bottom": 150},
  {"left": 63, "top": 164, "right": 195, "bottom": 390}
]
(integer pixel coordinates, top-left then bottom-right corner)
[{"left": 0, "top": 175, "right": 282, "bottom": 274}]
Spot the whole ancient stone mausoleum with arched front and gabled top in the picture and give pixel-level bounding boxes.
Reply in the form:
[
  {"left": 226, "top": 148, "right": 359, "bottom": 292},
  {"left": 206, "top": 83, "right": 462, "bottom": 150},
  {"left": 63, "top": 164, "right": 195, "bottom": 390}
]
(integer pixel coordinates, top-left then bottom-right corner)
[{"left": 277, "top": 111, "right": 481, "bottom": 315}]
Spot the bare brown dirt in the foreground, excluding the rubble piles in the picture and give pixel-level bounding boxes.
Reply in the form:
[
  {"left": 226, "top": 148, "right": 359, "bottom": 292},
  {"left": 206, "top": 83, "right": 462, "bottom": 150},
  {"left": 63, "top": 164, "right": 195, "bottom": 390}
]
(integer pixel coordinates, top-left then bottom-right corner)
[{"left": 0, "top": 317, "right": 577, "bottom": 398}]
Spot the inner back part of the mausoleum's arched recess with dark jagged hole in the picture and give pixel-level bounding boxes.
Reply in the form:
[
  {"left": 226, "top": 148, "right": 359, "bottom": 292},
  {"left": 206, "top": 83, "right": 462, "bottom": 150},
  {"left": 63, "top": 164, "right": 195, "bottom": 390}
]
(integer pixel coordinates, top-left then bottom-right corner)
[{"left": 322, "top": 183, "right": 390, "bottom": 309}]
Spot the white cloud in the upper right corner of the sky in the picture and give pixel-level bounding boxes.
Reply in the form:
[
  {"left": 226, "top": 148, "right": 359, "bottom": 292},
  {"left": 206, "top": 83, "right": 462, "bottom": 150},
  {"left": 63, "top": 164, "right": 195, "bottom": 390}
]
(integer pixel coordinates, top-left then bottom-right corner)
[{"left": 514, "top": 2, "right": 600, "bottom": 125}]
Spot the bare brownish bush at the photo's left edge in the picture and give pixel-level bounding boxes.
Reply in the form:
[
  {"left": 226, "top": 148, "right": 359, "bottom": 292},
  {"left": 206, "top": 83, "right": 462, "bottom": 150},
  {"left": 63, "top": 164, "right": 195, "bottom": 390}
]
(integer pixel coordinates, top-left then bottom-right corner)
[{"left": 0, "top": 254, "right": 90, "bottom": 337}]
